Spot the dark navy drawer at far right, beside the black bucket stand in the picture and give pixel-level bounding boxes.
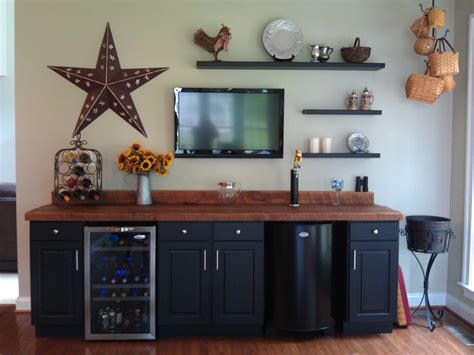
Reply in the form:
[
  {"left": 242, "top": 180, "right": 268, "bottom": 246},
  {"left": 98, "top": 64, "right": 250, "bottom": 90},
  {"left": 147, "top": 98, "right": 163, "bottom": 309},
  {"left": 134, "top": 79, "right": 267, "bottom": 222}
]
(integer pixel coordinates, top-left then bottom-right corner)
[{"left": 349, "top": 222, "right": 399, "bottom": 241}]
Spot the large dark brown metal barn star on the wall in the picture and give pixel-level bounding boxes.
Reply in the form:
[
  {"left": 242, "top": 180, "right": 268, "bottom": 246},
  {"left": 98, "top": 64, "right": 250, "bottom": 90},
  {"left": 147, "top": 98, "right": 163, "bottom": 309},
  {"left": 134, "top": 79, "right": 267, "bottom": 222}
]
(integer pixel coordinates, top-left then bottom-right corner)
[{"left": 48, "top": 23, "right": 169, "bottom": 137}]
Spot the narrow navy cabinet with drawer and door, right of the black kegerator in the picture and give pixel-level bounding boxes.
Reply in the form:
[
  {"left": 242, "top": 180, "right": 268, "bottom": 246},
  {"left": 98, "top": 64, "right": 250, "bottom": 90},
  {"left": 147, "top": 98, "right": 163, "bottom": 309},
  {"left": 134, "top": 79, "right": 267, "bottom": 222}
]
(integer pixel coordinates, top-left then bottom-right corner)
[{"left": 344, "top": 222, "right": 399, "bottom": 333}]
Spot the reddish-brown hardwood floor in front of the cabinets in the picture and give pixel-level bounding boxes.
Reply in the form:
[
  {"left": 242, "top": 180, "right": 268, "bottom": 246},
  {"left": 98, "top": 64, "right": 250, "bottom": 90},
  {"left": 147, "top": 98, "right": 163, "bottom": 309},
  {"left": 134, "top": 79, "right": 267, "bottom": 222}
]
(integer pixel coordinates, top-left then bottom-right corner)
[{"left": 0, "top": 306, "right": 474, "bottom": 355}]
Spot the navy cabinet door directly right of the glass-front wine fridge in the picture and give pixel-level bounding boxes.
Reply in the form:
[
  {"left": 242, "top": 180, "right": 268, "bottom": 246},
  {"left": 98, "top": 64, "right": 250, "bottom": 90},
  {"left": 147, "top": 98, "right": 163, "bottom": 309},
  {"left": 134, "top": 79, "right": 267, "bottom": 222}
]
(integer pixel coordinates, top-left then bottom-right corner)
[{"left": 158, "top": 241, "right": 211, "bottom": 325}]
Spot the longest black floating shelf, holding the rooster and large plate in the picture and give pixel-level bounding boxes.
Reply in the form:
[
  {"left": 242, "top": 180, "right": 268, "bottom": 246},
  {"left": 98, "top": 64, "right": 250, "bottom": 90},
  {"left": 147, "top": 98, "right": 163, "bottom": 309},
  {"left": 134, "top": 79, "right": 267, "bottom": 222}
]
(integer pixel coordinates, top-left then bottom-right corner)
[{"left": 196, "top": 61, "right": 385, "bottom": 71}]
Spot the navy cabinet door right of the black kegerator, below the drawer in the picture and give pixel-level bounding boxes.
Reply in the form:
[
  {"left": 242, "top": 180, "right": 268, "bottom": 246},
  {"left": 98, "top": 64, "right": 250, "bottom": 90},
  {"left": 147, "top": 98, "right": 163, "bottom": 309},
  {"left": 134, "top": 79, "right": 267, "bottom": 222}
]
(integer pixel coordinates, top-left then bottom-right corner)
[{"left": 348, "top": 241, "right": 398, "bottom": 322}]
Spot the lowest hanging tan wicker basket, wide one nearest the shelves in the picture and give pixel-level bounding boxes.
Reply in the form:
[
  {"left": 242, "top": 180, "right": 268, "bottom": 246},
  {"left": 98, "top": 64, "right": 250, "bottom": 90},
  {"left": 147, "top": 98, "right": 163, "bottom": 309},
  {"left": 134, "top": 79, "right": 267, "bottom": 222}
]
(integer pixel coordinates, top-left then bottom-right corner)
[{"left": 405, "top": 74, "right": 444, "bottom": 104}]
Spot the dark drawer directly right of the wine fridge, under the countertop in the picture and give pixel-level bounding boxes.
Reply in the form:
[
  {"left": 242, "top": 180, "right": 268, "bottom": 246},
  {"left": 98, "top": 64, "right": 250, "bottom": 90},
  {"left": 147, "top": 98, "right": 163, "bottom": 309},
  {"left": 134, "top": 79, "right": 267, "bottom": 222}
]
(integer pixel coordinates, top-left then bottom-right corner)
[{"left": 158, "top": 222, "right": 212, "bottom": 241}]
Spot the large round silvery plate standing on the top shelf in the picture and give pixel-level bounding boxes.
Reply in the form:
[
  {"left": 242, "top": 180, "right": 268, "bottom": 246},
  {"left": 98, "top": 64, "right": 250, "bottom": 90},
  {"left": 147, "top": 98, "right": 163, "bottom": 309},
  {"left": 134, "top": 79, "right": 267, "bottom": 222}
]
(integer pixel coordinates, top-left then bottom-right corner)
[{"left": 262, "top": 19, "right": 303, "bottom": 59}]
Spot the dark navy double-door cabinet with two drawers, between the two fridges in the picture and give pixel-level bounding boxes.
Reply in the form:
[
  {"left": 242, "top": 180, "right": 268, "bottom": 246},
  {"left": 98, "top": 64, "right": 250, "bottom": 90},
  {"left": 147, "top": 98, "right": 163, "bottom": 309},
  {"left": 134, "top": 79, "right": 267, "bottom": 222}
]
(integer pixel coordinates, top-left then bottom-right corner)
[{"left": 157, "top": 222, "right": 264, "bottom": 336}]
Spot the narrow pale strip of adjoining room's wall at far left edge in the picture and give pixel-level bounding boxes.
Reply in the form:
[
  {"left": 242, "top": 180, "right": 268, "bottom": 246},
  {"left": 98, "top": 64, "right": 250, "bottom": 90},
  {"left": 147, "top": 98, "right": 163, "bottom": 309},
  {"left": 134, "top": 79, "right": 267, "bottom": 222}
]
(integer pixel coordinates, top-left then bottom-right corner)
[{"left": 0, "top": 0, "right": 15, "bottom": 182}]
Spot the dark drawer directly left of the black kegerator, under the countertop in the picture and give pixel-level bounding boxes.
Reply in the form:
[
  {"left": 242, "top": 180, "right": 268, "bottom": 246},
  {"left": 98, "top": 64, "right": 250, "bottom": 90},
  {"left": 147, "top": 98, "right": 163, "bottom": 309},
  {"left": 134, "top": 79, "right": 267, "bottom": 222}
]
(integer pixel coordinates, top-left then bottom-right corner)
[{"left": 214, "top": 222, "right": 264, "bottom": 241}]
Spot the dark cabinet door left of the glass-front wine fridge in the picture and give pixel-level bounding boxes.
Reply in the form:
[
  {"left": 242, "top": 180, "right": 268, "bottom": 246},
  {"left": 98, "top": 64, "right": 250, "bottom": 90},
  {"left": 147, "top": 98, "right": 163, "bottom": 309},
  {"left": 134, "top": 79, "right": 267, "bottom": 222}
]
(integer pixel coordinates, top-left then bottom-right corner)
[{"left": 31, "top": 241, "right": 84, "bottom": 326}]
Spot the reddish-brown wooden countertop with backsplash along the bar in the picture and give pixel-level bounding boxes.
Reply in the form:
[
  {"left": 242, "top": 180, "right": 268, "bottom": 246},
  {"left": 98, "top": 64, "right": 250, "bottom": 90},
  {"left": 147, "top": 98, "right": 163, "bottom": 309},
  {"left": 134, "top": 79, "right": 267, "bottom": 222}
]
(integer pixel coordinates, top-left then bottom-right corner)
[{"left": 25, "top": 191, "right": 403, "bottom": 222}]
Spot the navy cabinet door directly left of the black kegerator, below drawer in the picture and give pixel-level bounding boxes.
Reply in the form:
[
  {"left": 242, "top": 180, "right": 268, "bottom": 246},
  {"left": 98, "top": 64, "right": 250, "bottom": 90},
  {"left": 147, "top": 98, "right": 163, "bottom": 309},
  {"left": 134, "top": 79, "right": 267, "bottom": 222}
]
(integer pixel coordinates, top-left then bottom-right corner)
[{"left": 213, "top": 242, "right": 264, "bottom": 325}]
